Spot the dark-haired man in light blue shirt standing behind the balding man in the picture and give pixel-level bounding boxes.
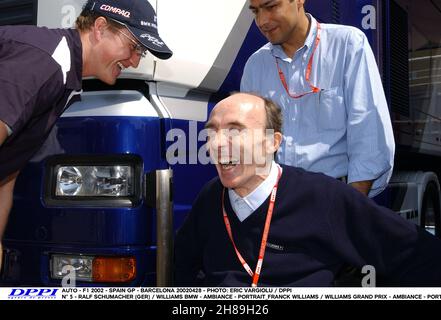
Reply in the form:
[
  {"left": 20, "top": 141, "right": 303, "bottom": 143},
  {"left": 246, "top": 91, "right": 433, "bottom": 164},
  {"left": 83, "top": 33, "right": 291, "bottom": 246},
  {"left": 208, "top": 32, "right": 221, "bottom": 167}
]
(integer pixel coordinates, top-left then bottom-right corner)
[{"left": 241, "top": 0, "right": 395, "bottom": 197}]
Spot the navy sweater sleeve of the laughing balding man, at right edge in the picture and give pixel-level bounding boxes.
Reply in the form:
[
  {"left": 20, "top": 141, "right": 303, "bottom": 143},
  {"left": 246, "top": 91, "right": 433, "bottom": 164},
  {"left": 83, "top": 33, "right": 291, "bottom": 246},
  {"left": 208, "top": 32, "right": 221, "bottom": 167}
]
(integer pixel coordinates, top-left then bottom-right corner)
[{"left": 329, "top": 185, "right": 441, "bottom": 286}]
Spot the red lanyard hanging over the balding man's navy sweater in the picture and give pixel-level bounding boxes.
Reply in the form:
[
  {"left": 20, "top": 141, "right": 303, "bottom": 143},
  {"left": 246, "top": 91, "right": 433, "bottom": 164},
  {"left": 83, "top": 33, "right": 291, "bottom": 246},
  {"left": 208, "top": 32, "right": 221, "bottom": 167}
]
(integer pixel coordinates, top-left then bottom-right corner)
[{"left": 222, "top": 167, "right": 282, "bottom": 287}]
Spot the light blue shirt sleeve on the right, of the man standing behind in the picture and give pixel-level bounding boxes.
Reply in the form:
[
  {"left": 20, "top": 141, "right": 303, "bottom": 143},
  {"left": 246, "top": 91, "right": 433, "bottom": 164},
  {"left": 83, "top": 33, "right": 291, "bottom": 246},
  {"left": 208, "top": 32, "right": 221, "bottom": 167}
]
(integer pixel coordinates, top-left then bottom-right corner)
[{"left": 344, "top": 29, "right": 395, "bottom": 197}]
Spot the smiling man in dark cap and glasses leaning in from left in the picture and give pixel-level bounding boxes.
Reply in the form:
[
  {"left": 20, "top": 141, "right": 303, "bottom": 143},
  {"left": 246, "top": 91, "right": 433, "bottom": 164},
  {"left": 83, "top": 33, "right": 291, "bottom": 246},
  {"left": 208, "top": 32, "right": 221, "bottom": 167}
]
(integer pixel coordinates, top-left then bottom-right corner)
[{"left": 0, "top": 0, "right": 172, "bottom": 268}]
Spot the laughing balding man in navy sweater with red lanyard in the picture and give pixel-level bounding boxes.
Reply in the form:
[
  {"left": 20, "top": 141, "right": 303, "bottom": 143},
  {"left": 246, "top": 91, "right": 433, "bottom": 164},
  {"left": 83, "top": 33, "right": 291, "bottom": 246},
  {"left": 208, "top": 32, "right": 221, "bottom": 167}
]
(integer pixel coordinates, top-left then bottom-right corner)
[{"left": 175, "top": 93, "right": 441, "bottom": 286}]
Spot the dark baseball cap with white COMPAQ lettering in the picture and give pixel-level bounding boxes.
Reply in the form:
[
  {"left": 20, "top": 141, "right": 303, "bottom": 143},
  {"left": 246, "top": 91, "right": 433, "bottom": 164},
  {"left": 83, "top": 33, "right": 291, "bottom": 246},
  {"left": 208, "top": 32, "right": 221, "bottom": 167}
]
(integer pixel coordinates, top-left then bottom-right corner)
[{"left": 84, "top": 0, "right": 173, "bottom": 59}]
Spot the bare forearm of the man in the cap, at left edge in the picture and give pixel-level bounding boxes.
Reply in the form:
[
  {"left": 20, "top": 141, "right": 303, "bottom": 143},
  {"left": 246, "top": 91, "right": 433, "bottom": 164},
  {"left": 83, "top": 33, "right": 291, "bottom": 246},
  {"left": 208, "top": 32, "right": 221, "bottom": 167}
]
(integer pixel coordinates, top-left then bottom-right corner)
[{"left": 0, "top": 171, "right": 18, "bottom": 271}]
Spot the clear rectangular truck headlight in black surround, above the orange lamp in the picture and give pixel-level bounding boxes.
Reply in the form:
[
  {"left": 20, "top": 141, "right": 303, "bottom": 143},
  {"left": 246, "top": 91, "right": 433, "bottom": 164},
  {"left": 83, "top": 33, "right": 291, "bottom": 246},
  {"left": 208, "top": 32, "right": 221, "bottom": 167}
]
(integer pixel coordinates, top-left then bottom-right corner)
[{"left": 45, "top": 155, "right": 142, "bottom": 207}]
